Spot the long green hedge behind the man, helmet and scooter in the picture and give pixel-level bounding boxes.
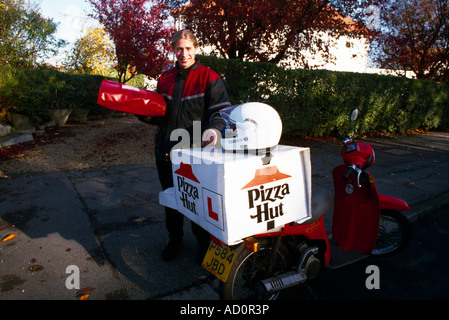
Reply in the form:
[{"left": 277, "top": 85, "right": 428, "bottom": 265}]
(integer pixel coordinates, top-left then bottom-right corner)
[{"left": 200, "top": 57, "right": 449, "bottom": 136}]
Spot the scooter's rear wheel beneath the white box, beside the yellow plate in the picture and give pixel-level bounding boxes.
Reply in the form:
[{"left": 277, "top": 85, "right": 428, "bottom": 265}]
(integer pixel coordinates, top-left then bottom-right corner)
[{"left": 219, "top": 239, "right": 289, "bottom": 300}]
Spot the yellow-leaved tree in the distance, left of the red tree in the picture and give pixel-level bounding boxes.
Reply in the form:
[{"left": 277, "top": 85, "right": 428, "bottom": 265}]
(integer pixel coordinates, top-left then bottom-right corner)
[{"left": 65, "top": 27, "right": 115, "bottom": 75}]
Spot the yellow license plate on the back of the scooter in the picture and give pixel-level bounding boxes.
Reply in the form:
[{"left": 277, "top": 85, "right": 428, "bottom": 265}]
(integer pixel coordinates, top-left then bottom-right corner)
[{"left": 203, "top": 241, "right": 236, "bottom": 282}]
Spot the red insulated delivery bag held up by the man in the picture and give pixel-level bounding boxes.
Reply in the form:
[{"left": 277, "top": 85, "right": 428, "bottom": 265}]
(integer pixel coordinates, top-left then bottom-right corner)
[{"left": 97, "top": 80, "right": 166, "bottom": 117}]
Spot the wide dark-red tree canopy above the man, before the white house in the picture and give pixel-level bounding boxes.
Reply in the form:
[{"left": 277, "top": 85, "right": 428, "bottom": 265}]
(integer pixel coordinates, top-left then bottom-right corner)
[{"left": 167, "top": 0, "right": 382, "bottom": 67}]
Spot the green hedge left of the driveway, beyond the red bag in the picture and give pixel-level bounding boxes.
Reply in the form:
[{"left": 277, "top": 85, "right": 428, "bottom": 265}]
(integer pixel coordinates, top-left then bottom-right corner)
[{"left": 0, "top": 67, "right": 104, "bottom": 123}]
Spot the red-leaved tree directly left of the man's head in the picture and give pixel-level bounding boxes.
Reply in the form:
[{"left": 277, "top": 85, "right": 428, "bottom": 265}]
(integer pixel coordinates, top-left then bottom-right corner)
[{"left": 89, "top": 0, "right": 172, "bottom": 83}]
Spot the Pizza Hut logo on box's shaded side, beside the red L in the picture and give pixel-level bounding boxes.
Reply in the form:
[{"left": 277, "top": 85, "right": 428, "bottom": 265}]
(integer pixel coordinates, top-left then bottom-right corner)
[{"left": 175, "top": 162, "right": 200, "bottom": 214}]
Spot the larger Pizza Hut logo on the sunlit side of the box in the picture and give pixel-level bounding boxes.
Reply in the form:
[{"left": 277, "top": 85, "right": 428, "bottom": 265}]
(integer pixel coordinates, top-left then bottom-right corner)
[{"left": 242, "top": 166, "right": 291, "bottom": 230}]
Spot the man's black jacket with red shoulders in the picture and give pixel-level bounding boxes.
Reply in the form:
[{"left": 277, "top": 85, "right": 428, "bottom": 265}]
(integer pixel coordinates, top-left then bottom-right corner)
[{"left": 155, "top": 60, "right": 231, "bottom": 156}]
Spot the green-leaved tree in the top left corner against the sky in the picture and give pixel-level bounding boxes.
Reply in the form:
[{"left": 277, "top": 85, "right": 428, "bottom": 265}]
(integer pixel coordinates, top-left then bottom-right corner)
[{"left": 0, "top": 0, "right": 65, "bottom": 67}]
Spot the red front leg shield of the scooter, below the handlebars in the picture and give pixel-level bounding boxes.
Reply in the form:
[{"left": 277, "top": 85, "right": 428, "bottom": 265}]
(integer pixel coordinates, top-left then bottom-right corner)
[{"left": 332, "top": 165, "right": 380, "bottom": 253}]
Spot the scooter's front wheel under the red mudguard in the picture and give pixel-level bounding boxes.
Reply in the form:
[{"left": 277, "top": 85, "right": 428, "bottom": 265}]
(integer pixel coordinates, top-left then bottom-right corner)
[{"left": 371, "top": 210, "right": 412, "bottom": 257}]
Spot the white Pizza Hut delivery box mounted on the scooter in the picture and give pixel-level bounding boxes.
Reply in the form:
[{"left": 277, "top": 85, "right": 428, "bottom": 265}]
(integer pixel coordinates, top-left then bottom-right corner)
[{"left": 159, "top": 145, "right": 312, "bottom": 245}]
